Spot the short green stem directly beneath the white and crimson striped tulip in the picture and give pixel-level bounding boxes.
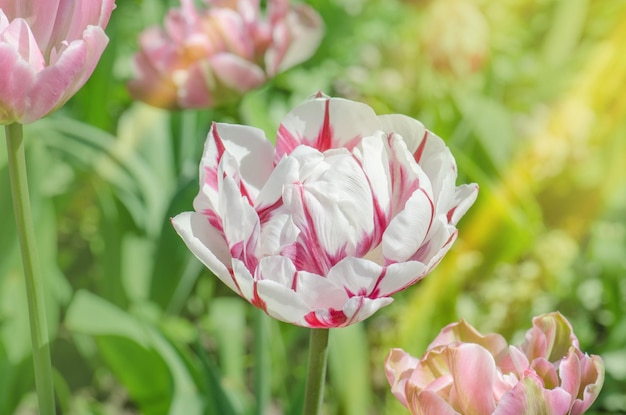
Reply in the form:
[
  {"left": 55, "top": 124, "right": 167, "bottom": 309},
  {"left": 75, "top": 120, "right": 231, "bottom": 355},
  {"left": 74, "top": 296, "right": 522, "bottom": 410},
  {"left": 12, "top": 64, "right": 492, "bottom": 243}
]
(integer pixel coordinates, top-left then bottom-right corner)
[{"left": 302, "top": 329, "right": 329, "bottom": 415}]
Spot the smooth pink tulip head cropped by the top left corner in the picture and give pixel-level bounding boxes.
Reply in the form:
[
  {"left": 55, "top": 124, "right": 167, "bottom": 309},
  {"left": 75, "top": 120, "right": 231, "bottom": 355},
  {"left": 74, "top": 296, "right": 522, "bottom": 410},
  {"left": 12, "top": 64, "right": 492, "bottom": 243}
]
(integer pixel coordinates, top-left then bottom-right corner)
[{"left": 0, "top": 0, "right": 115, "bottom": 124}]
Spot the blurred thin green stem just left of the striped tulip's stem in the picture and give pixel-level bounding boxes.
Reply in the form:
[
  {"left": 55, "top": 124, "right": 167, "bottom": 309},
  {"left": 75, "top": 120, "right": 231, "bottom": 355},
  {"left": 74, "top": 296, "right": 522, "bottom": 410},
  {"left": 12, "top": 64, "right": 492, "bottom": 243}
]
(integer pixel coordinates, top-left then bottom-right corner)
[{"left": 253, "top": 309, "right": 271, "bottom": 415}]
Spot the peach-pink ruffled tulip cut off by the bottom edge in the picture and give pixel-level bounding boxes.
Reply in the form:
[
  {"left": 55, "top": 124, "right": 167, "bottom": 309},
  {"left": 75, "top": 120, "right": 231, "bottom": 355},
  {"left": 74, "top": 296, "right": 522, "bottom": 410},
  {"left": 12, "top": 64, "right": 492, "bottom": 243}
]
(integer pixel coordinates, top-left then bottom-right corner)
[{"left": 386, "top": 313, "right": 604, "bottom": 415}]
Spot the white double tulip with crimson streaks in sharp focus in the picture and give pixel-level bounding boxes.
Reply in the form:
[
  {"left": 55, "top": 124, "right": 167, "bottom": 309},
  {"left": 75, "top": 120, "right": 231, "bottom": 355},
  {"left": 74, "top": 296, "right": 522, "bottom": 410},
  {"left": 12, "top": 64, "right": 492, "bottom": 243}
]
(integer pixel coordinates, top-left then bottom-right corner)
[{"left": 172, "top": 94, "right": 478, "bottom": 328}]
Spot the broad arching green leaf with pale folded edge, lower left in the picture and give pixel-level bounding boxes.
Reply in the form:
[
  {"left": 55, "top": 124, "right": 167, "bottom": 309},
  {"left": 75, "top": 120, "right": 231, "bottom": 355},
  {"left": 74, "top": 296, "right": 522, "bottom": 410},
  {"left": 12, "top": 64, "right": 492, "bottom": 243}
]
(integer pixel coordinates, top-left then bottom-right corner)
[{"left": 65, "top": 291, "right": 204, "bottom": 415}]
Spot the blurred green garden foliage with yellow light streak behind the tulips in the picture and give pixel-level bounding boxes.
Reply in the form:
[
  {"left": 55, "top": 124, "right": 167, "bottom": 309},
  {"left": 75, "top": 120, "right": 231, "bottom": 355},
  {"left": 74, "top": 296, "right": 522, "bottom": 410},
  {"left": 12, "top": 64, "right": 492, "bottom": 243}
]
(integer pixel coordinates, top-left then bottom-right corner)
[{"left": 0, "top": 0, "right": 626, "bottom": 415}]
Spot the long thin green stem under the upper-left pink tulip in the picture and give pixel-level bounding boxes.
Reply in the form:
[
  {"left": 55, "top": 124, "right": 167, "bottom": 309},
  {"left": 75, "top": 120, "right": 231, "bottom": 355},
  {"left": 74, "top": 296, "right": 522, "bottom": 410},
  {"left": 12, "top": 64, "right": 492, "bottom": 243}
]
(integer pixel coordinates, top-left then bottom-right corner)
[{"left": 5, "top": 123, "right": 55, "bottom": 415}]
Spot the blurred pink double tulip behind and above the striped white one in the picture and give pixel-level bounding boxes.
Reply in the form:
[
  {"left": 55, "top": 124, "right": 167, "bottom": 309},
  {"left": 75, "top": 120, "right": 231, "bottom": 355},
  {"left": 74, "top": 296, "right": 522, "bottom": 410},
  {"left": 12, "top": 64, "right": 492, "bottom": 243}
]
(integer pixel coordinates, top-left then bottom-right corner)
[{"left": 128, "top": 0, "right": 323, "bottom": 109}]
